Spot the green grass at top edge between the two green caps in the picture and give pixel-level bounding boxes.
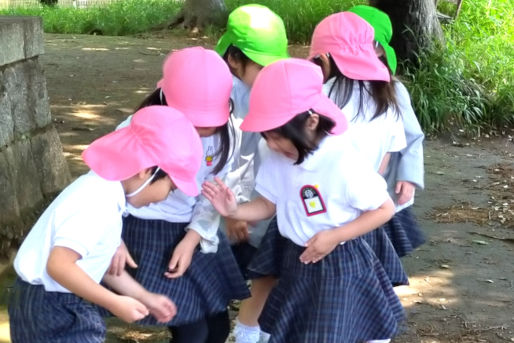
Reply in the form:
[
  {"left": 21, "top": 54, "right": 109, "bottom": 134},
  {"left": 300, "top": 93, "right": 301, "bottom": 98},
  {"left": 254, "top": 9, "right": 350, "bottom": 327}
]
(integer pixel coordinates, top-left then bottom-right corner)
[{"left": 225, "top": 0, "right": 367, "bottom": 44}]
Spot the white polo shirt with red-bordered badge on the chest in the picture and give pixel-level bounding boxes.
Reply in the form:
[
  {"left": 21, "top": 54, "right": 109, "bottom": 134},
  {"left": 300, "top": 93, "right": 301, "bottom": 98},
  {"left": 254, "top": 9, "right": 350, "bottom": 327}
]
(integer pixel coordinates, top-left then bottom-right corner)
[{"left": 256, "top": 134, "right": 389, "bottom": 246}]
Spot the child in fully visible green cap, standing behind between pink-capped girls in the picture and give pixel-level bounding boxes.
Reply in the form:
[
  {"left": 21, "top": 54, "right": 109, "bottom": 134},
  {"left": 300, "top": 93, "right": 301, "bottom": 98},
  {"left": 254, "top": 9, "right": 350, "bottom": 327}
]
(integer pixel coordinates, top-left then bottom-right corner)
[{"left": 215, "top": 4, "right": 289, "bottom": 343}]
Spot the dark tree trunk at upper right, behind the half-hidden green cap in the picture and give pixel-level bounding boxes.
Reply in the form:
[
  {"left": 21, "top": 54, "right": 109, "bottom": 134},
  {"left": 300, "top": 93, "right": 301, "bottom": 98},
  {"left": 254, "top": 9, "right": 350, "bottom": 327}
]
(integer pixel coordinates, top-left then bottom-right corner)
[{"left": 370, "top": 0, "right": 443, "bottom": 63}]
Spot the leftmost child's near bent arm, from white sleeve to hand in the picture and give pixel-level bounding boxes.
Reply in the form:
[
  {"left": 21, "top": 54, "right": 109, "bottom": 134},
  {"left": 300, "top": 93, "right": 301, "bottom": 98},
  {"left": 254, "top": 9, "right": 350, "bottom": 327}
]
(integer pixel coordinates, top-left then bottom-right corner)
[{"left": 46, "top": 246, "right": 149, "bottom": 322}]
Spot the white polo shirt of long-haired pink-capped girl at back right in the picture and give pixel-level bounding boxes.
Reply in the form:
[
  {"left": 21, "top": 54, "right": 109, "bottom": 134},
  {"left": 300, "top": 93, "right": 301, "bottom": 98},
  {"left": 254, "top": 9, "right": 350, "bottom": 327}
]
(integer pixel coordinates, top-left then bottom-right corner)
[{"left": 323, "top": 78, "right": 407, "bottom": 171}]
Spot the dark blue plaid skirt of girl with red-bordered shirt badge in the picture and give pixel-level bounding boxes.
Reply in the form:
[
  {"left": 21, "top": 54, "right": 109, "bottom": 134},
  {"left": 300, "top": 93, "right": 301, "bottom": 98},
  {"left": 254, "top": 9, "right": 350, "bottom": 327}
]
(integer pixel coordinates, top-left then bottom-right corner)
[{"left": 259, "top": 238, "right": 404, "bottom": 343}]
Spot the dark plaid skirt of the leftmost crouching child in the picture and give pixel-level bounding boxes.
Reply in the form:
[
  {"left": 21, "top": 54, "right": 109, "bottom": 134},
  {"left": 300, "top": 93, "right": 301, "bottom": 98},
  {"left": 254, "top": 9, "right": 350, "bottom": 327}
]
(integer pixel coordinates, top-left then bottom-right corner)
[{"left": 8, "top": 278, "right": 106, "bottom": 343}]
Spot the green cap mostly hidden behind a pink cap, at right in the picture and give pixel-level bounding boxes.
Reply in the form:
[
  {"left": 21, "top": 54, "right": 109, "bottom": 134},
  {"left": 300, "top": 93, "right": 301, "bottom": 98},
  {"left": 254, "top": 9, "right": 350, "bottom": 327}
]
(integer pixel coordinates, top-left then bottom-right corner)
[{"left": 348, "top": 5, "right": 397, "bottom": 74}]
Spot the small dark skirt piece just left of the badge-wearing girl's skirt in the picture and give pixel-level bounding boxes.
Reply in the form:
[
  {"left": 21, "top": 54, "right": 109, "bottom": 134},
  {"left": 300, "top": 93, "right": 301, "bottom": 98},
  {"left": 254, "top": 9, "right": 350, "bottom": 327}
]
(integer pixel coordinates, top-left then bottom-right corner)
[{"left": 247, "top": 217, "right": 287, "bottom": 279}]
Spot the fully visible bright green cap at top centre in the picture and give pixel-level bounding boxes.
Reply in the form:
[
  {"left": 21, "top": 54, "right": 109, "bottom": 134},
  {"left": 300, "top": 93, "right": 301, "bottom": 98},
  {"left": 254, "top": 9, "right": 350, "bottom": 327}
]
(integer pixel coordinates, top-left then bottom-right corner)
[{"left": 215, "top": 4, "right": 289, "bottom": 66}]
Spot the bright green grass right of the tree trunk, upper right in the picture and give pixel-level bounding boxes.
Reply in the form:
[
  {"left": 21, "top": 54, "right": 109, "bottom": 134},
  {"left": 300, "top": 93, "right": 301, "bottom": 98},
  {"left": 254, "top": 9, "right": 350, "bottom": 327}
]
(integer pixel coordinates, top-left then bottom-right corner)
[{"left": 403, "top": 0, "right": 514, "bottom": 132}]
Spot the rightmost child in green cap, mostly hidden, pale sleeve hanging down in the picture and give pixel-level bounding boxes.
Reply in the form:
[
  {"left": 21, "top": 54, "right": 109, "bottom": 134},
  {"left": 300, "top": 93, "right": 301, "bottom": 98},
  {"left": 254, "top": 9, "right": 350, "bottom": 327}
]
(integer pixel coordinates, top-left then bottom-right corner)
[{"left": 348, "top": 5, "right": 425, "bottom": 257}]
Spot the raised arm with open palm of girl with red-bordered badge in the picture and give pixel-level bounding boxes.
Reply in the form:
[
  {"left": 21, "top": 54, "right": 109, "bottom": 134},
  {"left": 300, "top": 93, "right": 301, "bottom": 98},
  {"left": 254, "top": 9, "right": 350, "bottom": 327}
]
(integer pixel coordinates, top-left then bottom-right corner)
[{"left": 202, "top": 178, "right": 276, "bottom": 221}]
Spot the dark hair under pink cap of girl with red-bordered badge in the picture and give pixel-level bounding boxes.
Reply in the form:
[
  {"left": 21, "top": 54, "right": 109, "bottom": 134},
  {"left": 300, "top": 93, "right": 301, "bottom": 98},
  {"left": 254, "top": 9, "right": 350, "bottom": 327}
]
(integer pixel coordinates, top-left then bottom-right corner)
[{"left": 261, "top": 110, "right": 335, "bottom": 164}]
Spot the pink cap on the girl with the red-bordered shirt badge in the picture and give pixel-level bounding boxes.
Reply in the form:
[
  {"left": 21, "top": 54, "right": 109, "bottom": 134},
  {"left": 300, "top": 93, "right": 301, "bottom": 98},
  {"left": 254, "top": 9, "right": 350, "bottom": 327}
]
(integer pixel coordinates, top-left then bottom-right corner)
[{"left": 241, "top": 58, "right": 347, "bottom": 135}]
